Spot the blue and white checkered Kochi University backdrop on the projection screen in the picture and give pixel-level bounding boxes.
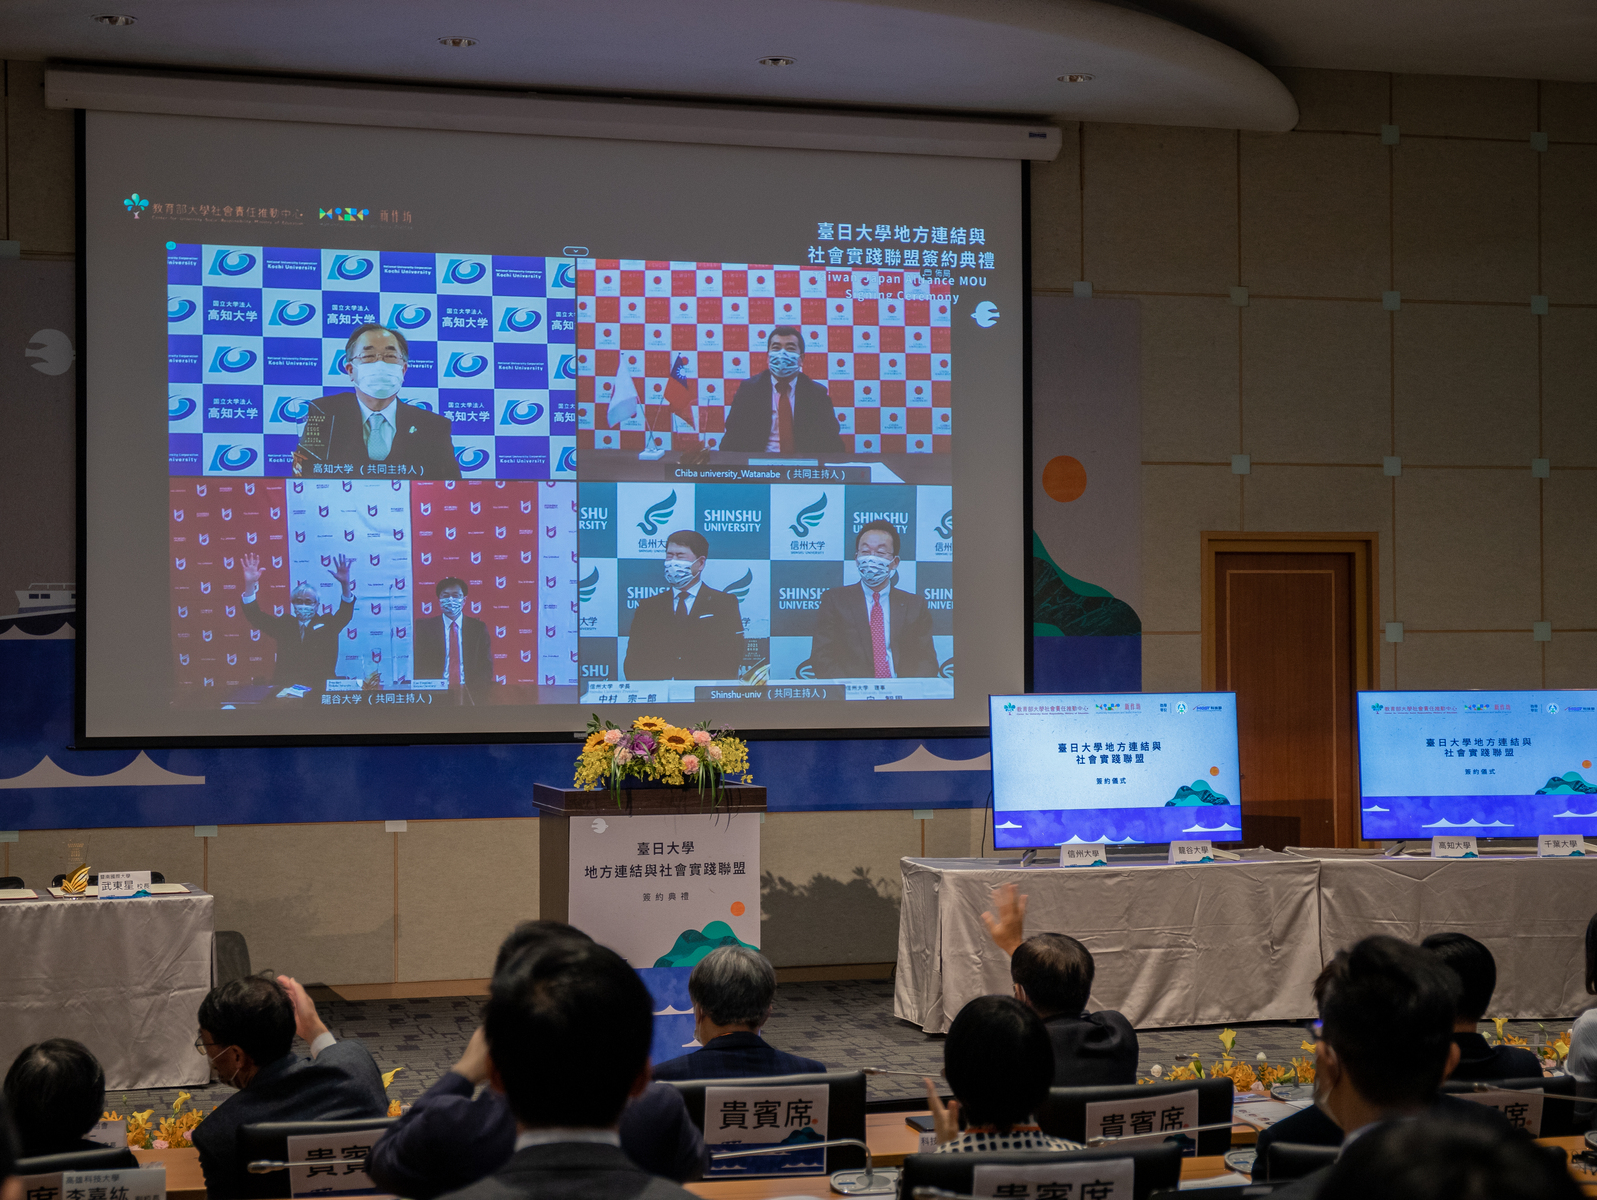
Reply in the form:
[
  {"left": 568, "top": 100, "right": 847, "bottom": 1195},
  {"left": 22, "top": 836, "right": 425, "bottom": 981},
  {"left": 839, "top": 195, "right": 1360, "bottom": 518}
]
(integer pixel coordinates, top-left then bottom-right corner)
[{"left": 166, "top": 243, "right": 577, "bottom": 479}]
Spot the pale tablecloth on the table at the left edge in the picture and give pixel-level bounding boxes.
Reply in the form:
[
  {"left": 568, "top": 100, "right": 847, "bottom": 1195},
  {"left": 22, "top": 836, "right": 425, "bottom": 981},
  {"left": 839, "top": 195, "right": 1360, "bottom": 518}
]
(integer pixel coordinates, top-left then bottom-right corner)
[{"left": 0, "top": 885, "right": 214, "bottom": 1091}]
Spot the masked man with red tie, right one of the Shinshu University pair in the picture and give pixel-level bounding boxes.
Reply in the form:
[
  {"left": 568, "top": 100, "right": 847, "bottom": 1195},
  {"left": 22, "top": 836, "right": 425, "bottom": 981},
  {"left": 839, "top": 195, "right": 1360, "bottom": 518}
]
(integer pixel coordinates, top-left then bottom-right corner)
[{"left": 810, "top": 521, "right": 937, "bottom": 679}]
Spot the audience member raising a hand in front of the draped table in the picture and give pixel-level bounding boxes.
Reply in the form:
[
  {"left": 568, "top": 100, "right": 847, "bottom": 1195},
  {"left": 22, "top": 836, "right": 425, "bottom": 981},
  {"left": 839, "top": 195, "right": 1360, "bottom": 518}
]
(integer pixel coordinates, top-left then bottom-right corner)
[{"left": 982, "top": 884, "right": 1137, "bottom": 1088}]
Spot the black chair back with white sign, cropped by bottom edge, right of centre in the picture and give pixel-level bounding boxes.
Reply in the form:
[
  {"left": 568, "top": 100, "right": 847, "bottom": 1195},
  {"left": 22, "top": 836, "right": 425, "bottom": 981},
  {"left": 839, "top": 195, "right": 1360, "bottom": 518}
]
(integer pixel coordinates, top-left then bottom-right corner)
[{"left": 899, "top": 1142, "right": 1182, "bottom": 1200}]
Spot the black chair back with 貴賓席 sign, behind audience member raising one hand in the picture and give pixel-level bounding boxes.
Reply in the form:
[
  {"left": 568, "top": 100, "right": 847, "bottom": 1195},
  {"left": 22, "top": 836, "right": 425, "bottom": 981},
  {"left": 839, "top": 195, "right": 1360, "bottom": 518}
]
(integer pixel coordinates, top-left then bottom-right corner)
[{"left": 1035, "top": 1079, "right": 1236, "bottom": 1154}]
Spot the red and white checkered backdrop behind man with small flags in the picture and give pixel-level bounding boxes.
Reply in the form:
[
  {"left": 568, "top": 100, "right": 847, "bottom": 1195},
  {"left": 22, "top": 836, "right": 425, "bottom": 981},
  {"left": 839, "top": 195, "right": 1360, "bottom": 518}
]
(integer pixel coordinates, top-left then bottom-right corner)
[{"left": 577, "top": 259, "right": 953, "bottom": 454}]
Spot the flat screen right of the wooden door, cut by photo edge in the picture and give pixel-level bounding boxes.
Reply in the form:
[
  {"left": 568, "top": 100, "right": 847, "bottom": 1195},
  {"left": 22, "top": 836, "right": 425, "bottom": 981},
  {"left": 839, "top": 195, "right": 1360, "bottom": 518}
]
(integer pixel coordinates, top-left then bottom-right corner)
[{"left": 1359, "top": 690, "right": 1597, "bottom": 840}]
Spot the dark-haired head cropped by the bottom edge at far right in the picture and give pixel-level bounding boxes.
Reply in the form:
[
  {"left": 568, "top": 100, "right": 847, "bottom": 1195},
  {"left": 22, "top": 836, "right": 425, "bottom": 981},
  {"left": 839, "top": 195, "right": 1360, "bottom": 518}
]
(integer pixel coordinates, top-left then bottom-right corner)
[{"left": 1303, "top": 1115, "right": 1581, "bottom": 1200}]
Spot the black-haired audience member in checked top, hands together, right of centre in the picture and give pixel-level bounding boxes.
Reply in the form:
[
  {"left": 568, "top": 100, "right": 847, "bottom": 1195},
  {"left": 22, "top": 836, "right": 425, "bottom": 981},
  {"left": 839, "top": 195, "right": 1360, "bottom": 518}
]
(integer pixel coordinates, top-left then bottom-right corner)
[{"left": 926, "top": 995, "right": 1081, "bottom": 1154}]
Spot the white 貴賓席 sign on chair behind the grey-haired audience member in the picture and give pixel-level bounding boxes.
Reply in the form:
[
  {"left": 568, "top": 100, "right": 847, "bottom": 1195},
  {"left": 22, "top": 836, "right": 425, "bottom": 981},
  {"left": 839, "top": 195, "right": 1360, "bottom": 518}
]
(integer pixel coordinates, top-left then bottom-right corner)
[{"left": 704, "top": 1083, "right": 829, "bottom": 1179}]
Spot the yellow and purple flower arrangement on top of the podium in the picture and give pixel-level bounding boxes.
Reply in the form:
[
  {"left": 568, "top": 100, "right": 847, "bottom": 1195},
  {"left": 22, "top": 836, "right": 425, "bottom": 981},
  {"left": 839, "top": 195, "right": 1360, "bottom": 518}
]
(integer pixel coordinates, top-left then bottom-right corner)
[{"left": 573, "top": 713, "right": 754, "bottom": 809}]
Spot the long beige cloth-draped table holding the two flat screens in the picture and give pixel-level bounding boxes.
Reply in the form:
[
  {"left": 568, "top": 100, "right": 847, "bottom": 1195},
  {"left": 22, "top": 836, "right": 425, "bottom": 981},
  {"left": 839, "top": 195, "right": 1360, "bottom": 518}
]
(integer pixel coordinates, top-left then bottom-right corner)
[{"left": 893, "top": 847, "right": 1597, "bottom": 1034}]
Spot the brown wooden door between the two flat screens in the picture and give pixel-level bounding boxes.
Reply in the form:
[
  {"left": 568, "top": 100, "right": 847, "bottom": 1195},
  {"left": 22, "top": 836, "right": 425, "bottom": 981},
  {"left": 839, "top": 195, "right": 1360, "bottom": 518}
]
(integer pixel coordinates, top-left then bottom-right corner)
[{"left": 1209, "top": 551, "right": 1359, "bottom": 850}]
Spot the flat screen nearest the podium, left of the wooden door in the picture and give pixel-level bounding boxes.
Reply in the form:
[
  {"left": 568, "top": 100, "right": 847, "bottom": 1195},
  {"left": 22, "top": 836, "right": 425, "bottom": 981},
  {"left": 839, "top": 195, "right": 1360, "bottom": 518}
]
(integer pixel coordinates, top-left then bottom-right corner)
[{"left": 989, "top": 692, "right": 1242, "bottom": 850}]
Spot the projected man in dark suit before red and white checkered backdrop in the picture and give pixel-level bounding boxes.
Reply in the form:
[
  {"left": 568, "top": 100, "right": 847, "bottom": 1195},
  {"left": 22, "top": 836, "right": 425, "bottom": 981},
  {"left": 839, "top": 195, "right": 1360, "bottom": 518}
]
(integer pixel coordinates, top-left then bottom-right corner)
[{"left": 720, "top": 324, "right": 846, "bottom": 457}]
